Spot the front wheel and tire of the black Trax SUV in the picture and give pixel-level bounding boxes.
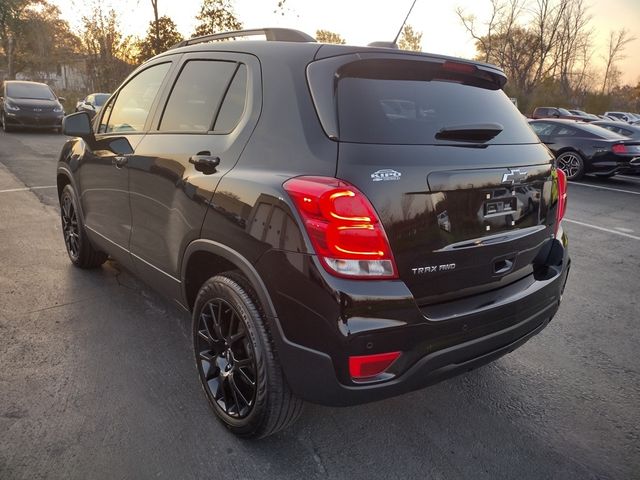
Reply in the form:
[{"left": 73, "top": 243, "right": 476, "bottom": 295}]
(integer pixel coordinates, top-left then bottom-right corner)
[{"left": 60, "top": 185, "right": 107, "bottom": 268}]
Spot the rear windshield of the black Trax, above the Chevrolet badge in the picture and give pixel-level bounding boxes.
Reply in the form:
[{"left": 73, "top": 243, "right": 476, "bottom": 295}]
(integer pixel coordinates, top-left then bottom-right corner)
[{"left": 337, "top": 60, "right": 539, "bottom": 145}]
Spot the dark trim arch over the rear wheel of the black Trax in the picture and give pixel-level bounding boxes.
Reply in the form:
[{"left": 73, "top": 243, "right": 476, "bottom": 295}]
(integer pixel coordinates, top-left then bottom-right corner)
[{"left": 181, "top": 239, "right": 276, "bottom": 318}]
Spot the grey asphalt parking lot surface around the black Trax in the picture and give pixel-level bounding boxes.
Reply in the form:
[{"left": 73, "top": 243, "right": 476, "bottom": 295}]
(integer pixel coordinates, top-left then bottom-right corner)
[{"left": 0, "top": 128, "right": 640, "bottom": 480}]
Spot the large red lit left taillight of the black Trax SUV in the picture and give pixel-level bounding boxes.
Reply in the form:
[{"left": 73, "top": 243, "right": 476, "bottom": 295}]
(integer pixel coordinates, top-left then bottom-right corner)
[{"left": 284, "top": 177, "right": 397, "bottom": 279}]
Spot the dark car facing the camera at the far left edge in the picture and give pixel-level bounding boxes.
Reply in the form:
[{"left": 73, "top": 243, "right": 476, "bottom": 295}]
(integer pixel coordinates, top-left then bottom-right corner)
[{"left": 0, "top": 80, "right": 64, "bottom": 132}]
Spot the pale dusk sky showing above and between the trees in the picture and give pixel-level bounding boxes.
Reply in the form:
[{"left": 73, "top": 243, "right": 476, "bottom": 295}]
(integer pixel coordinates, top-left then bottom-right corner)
[{"left": 57, "top": 0, "right": 640, "bottom": 84}]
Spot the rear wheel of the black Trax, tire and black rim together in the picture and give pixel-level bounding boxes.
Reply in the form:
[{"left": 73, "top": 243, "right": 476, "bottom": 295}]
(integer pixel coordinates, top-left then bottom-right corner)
[{"left": 193, "top": 272, "right": 303, "bottom": 438}]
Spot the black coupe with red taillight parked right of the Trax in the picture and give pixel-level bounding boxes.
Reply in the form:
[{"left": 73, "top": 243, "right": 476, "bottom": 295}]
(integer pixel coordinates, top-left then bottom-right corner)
[{"left": 529, "top": 119, "right": 640, "bottom": 180}]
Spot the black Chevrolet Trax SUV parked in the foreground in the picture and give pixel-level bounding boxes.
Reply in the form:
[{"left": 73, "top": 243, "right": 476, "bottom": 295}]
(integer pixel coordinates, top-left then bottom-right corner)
[{"left": 57, "top": 29, "right": 569, "bottom": 437}]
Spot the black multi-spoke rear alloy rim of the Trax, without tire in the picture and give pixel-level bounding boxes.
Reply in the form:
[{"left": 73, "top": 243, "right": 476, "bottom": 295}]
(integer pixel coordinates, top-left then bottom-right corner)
[{"left": 196, "top": 299, "right": 257, "bottom": 419}]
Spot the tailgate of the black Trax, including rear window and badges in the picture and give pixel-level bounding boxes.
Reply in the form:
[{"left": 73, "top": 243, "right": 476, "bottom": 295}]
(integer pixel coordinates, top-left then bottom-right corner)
[{"left": 312, "top": 58, "right": 554, "bottom": 304}]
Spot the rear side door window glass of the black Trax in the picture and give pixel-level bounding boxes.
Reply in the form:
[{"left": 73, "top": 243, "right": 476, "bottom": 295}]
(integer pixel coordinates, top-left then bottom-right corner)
[{"left": 160, "top": 60, "right": 237, "bottom": 132}]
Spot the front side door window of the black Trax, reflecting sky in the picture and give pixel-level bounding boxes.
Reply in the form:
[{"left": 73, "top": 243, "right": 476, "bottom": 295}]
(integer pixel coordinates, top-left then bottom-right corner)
[{"left": 100, "top": 63, "right": 171, "bottom": 133}]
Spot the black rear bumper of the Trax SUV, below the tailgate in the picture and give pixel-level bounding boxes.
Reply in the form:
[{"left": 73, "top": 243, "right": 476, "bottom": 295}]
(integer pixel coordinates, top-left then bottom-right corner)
[{"left": 258, "top": 234, "right": 570, "bottom": 406}]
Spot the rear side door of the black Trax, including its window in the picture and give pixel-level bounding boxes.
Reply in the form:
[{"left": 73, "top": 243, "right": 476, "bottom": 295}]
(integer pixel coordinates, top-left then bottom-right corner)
[{"left": 129, "top": 52, "right": 260, "bottom": 295}]
